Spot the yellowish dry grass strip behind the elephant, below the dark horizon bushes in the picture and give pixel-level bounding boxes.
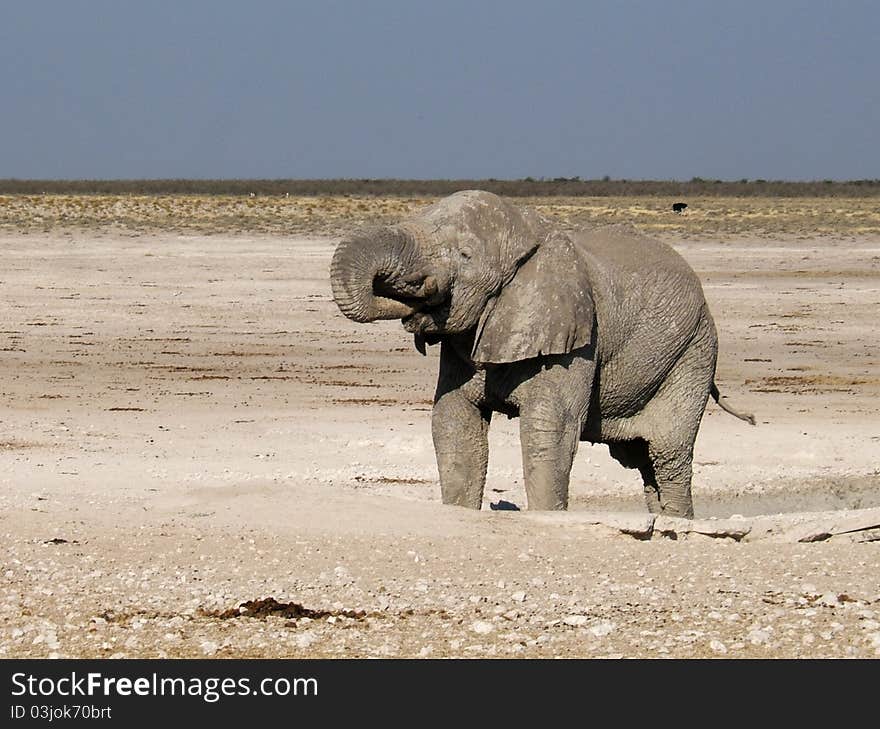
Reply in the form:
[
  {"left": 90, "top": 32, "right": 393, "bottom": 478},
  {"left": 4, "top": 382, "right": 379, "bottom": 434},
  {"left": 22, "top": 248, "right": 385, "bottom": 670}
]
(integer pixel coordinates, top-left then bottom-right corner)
[{"left": 0, "top": 195, "right": 880, "bottom": 240}]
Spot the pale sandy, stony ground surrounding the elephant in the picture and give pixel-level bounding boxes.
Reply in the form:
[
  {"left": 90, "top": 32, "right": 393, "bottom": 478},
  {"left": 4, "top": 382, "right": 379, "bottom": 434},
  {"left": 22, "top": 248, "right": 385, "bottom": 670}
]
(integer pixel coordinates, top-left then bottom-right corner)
[{"left": 0, "top": 215, "right": 880, "bottom": 658}]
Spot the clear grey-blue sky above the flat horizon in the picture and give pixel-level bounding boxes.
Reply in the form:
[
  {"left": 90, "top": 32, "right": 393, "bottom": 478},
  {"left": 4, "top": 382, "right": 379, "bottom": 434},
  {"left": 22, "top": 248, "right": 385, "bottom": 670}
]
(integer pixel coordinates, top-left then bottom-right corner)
[{"left": 0, "top": 0, "right": 880, "bottom": 180}]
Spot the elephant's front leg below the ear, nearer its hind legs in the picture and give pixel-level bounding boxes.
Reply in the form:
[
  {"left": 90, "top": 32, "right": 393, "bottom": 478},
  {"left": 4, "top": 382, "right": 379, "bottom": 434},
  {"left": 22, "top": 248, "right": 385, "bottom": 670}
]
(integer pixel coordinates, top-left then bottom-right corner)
[{"left": 520, "top": 403, "right": 581, "bottom": 510}]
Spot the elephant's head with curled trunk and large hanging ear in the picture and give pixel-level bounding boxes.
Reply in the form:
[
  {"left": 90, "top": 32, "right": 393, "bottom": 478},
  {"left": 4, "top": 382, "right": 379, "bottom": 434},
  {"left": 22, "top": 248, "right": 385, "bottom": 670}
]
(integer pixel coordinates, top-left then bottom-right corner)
[{"left": 330, "top": 190, "right": 593, "bottom": 365}]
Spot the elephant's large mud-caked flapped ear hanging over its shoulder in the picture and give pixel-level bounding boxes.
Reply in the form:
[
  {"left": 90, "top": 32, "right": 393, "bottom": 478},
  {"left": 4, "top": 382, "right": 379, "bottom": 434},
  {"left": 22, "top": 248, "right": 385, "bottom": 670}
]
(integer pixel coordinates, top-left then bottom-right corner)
[{"left": 471, "top": 233, "right": 595, "bottom": 365}]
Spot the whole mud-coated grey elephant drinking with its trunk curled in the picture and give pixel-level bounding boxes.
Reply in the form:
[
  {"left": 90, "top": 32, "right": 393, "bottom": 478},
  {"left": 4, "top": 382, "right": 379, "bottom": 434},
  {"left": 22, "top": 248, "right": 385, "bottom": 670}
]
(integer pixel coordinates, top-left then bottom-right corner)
[{"left": 330, "top": 190, "right": 754, "bottom": 517}]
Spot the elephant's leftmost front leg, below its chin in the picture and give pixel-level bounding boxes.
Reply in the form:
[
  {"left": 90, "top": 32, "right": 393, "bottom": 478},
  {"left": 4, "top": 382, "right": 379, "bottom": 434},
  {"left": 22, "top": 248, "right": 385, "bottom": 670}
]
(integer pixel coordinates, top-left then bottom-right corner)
[{"left": 431, "top": 390, "right": 492, "bottom": 509}]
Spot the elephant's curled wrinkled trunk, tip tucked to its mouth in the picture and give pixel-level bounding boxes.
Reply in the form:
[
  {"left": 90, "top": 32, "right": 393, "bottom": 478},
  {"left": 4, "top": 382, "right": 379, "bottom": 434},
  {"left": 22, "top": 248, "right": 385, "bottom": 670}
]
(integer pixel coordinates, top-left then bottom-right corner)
[{"left": 330, "top": 227, "right": 418, "bottom": 322}]
